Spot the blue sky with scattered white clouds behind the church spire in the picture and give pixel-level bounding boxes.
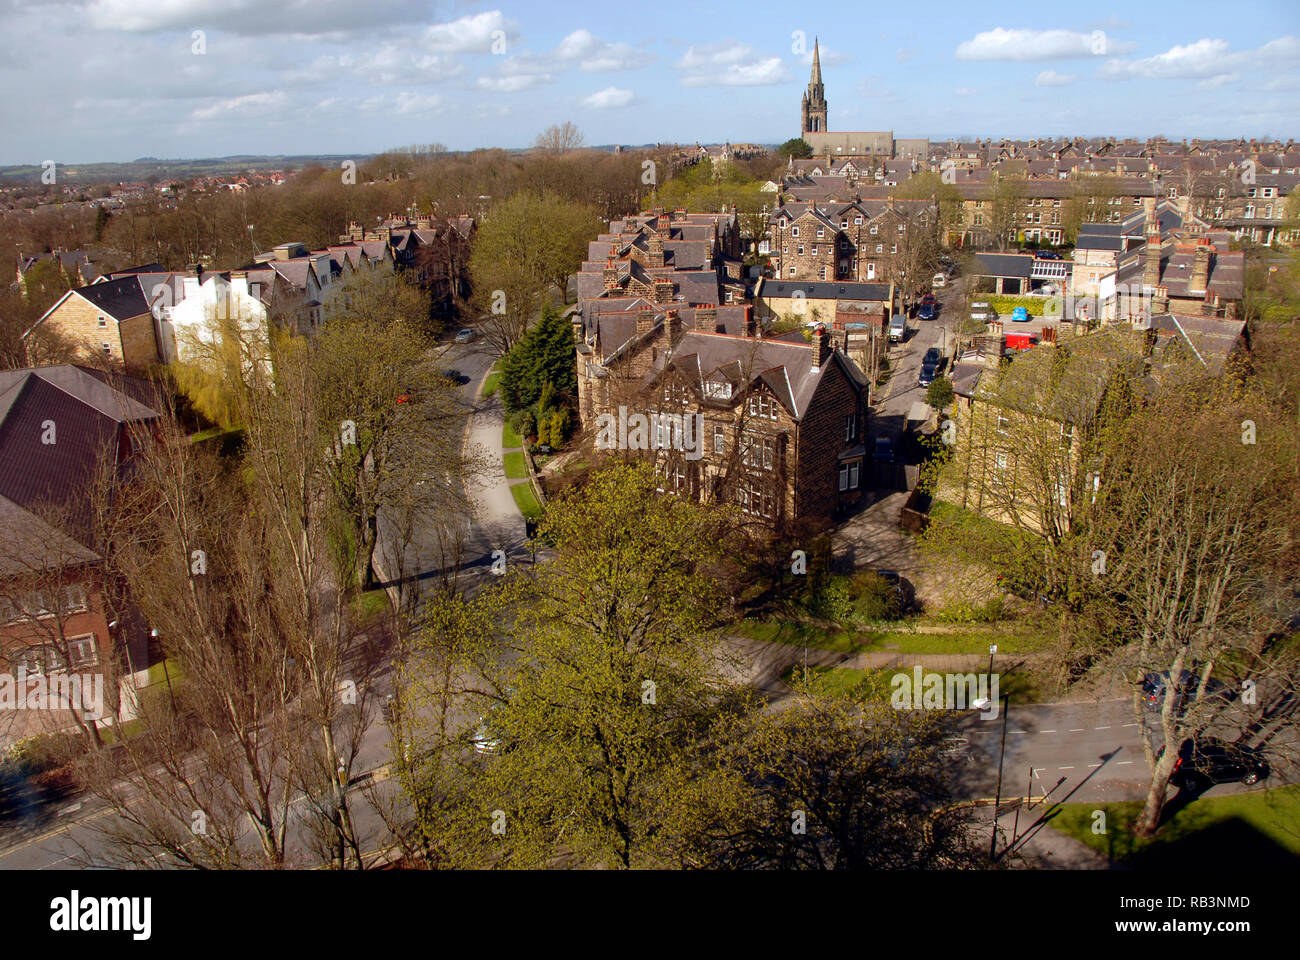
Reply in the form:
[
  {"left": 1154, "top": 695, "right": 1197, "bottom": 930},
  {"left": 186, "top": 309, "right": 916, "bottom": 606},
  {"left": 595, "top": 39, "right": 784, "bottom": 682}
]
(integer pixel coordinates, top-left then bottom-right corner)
[{"left": 0, "top": 0, "right": 1300, "bottom": 164}]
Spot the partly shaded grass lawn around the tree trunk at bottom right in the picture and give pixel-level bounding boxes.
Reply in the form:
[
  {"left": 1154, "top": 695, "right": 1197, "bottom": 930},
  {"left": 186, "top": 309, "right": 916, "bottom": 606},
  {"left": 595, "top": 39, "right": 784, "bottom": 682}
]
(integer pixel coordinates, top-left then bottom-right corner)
[{"left": 1050, "top": 786, "right": 1300, "bottom": 869}]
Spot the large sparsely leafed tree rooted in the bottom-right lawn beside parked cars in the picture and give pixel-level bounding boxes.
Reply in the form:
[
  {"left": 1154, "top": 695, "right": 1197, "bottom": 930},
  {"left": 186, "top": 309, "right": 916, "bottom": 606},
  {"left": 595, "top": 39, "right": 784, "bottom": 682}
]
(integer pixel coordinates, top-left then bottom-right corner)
[{"left": 1071, "top": 364, "right": 1300, "bottom": 836}]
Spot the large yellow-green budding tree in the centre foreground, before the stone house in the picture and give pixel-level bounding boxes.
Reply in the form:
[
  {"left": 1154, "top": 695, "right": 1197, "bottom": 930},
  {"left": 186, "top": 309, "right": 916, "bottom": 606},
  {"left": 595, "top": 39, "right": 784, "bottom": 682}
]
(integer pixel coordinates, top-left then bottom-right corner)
[{"left": 403, "top": 466, "right": 750, "bottom": 868}]
